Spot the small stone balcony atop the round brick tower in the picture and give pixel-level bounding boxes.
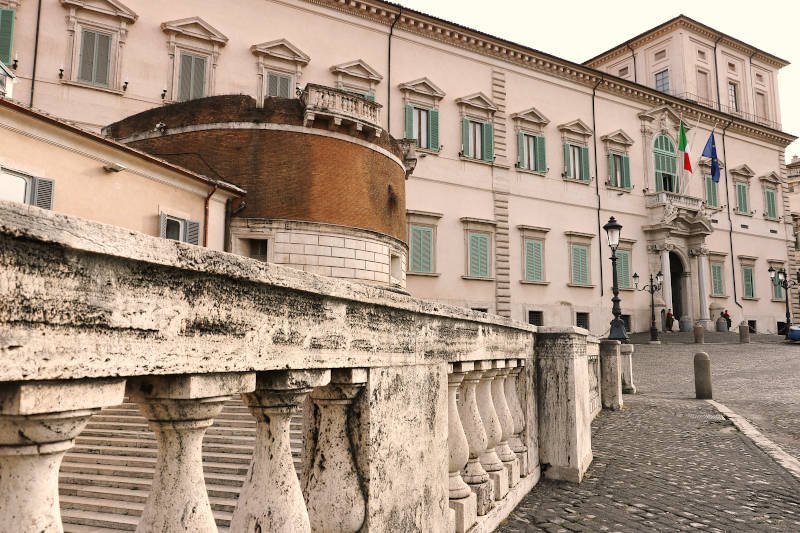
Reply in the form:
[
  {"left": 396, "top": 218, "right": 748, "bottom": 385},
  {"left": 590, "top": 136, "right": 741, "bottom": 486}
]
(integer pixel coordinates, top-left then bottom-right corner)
[{"left": 300, "top": 83, "right": 383, "bottom": 137}]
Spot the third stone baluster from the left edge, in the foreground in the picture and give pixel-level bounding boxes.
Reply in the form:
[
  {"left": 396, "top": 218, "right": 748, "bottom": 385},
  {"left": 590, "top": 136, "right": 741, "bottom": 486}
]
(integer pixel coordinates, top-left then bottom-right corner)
[{"left": 231, "top": 370, "right": 331, "bottom": 533}]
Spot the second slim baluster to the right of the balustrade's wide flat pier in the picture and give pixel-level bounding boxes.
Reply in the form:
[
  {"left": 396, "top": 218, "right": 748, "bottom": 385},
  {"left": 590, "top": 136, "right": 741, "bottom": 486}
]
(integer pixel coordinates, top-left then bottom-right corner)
[{"left": 455, "top": 361, "right": 494, "bottom": 516}]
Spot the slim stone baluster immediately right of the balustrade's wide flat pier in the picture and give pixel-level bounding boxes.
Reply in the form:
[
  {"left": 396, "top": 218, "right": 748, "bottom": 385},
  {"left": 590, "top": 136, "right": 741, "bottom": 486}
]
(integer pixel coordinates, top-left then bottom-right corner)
[{"left": 447, "top": 363, "right": 477, "bottom": 533}]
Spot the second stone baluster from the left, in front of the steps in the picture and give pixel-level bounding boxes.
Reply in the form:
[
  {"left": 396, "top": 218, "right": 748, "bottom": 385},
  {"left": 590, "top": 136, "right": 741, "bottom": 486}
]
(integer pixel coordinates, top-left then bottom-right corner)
[{"left": 128, "top": 372, "right": 256, "bottom": 533}]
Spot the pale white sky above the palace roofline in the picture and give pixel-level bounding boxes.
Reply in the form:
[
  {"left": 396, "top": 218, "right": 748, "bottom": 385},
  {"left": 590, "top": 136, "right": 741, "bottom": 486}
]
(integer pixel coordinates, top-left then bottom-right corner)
[{"left": 399, "top": 0, "right": 800, "bottom": 162}]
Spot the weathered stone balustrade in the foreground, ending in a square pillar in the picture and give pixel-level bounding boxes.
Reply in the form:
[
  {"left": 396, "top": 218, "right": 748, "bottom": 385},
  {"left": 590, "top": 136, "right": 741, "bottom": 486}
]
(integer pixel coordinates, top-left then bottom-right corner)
[{"left": 0, "top": 202, "right": 612, "bottom": 533}]
